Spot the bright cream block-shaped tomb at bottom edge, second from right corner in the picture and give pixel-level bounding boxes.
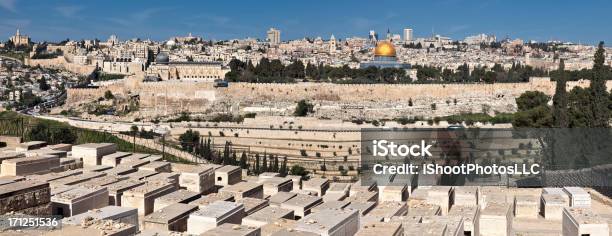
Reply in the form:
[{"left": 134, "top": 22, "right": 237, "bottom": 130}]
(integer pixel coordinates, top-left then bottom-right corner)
[{"left": 478, "top": 202, "right": 513, "bottom": 236}]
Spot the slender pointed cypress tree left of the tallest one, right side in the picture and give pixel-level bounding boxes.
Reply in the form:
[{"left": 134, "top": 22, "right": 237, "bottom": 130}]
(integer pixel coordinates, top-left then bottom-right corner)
[{"left": 553, "top": 59, "right": 569, "bottom": 128}]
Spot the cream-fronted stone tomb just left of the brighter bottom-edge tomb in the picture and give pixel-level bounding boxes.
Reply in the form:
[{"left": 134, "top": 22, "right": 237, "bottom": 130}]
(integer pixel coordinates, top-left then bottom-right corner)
[{"left": 143, "top": 203, "right": 198, "bottom": 232}]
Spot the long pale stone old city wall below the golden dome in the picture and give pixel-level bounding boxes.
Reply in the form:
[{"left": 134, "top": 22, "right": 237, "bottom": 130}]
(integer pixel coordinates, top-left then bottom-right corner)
[{"left": 68, "top": 78, "right": 612, "bottom": 115}]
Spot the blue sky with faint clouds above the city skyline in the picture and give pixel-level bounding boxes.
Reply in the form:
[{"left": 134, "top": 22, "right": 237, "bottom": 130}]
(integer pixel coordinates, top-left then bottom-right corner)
[{"left": 0, "top": 0, "right": 612, "bottom": 44}]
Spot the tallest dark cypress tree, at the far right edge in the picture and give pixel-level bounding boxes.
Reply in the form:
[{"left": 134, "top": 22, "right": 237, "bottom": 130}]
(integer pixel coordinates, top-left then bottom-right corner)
[{"left": 590, "top": 42, "right": 610, "bottom": 127}]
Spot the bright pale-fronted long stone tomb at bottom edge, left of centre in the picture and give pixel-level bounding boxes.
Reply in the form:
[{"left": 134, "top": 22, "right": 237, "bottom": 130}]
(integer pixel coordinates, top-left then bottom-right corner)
[{"left": 187, "top": 201, "right": 245, "bottom": 234}]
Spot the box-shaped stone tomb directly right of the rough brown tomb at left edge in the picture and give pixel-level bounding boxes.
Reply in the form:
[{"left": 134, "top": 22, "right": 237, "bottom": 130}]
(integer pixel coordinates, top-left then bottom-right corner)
[{"left": 51, "top": 187, "right": 108, "bottom": 216}]
